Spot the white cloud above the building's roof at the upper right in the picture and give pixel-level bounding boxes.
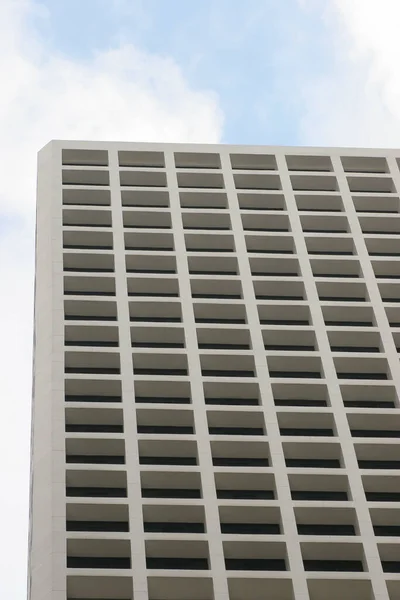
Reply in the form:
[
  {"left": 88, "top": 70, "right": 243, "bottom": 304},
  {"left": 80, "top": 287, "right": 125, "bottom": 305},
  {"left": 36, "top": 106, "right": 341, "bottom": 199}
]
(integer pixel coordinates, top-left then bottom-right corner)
[{"left": 301, "top": 0, "right": 400, "bottom": 147}]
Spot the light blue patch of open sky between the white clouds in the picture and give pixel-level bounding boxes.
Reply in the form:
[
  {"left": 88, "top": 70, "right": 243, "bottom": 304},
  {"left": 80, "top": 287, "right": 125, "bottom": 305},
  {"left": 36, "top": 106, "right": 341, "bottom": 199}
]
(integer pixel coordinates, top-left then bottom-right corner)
[{"left": 30, "top": 0, "right": 332, "bottom": 144}]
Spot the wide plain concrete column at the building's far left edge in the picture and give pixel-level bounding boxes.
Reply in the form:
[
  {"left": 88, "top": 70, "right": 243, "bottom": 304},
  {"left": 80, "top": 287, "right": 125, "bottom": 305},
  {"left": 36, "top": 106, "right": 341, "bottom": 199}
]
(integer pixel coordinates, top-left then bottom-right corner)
[{"left": 28, "top": 143, "right": 66, "bottom": 600}]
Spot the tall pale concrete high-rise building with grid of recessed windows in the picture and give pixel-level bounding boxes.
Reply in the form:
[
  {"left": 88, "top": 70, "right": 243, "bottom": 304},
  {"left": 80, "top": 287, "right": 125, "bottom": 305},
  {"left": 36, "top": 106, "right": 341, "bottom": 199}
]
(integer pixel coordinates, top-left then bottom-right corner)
[{"left": 29, "top": 141, "right": 400, "bottom": 600}]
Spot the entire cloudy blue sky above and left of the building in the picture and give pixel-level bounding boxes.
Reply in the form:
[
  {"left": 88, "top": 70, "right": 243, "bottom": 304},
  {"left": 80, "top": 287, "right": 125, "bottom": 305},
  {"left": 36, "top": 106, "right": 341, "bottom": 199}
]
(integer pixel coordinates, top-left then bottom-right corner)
[{"left": 0, "top": 0, "right": 400, "bottom": 600}]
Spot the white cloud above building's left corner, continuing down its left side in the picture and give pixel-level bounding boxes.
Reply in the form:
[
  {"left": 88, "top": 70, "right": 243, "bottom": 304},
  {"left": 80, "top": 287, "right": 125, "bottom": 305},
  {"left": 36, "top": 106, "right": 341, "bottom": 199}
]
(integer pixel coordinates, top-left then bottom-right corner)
[{"left": 0, "top": 0, "right": 222, "bottom": 600}]
